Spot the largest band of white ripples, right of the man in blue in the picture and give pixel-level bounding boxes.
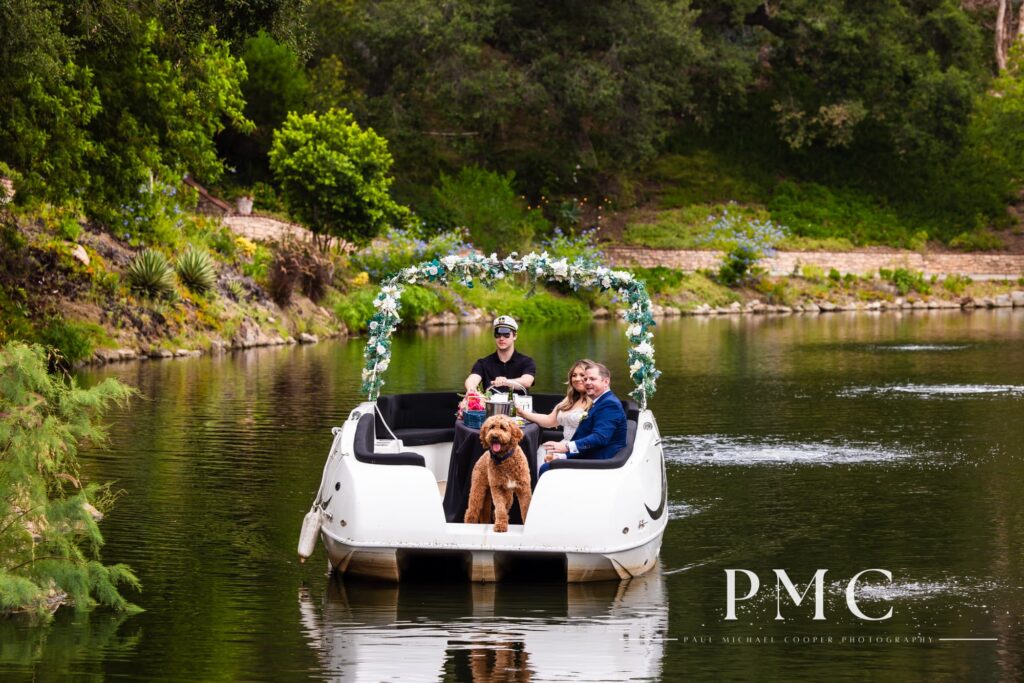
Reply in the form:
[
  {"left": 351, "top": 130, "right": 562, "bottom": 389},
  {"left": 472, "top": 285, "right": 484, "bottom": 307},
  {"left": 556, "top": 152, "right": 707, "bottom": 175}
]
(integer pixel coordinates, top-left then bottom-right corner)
[{"left": 663, "top": 434, "right": 916, "bottom": 466}]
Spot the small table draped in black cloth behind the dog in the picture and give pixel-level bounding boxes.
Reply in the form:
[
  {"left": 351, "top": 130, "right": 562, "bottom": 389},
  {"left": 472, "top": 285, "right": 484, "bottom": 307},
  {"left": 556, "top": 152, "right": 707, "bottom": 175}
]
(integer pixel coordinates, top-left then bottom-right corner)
[{"left": 444, "top": 420, "right": 541, "bottom": 524}]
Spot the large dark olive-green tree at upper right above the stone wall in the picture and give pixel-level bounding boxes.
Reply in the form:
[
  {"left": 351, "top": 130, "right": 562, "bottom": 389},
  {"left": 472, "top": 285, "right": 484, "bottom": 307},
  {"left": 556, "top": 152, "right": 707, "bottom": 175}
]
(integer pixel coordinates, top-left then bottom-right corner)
[{"left": 694, "top": 0, "right": 988, "bottom": 179}]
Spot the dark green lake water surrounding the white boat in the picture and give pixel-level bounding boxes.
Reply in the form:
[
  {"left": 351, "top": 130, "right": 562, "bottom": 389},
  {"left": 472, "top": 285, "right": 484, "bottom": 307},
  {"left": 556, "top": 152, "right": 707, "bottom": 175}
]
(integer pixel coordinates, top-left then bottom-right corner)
[{"left": 0, "top": 310, "right": 1024, "bottom": 681}]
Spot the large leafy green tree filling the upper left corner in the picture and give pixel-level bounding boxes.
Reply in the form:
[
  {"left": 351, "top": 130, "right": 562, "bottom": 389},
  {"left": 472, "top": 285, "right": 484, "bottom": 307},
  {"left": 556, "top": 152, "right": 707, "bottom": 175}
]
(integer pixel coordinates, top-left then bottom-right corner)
[{"left": 0, "top": 0, "right": 251, "bottom": 220}]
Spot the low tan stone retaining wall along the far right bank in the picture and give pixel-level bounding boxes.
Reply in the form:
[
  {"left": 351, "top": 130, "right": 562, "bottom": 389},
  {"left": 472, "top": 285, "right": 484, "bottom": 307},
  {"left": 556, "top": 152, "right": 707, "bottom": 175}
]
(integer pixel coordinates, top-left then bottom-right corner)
[{"left": 603, "top": 247, "right": 1024, "bottom": 280}]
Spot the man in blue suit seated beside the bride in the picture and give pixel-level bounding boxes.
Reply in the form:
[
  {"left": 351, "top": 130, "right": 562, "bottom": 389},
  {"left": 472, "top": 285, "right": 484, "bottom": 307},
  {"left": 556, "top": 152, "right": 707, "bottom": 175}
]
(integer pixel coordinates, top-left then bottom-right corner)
[{"left": 538, "top": 362, "right": 626, "bottom": 476}]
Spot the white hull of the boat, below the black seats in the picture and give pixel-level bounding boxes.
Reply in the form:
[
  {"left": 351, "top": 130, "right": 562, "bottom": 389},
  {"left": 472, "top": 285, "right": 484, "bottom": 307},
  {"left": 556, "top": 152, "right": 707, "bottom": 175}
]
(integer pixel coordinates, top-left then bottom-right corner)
[{"left": 307, "top": 403, "right": 668, "bottom": 583}]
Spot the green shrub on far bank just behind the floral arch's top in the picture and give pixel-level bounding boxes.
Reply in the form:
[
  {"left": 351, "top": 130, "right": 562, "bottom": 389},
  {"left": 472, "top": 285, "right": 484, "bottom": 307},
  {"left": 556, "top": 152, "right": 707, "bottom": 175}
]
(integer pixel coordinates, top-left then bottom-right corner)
[{"left": 435, "top": 166, "right": 548, "bottom": 254}]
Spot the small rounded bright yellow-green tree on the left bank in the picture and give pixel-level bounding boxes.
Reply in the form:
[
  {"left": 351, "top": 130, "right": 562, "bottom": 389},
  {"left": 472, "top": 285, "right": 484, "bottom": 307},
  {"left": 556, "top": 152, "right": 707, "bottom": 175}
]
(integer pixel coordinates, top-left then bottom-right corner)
[{"left": 270, "top": 110, "right": 404, "bottom": 249}]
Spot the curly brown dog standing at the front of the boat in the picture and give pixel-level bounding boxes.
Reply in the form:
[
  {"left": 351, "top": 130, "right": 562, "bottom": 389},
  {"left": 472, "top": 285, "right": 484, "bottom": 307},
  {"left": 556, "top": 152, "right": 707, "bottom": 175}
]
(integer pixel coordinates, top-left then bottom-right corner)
[{"left": 465, "top": 415, "right": 531, "bottom": 532}]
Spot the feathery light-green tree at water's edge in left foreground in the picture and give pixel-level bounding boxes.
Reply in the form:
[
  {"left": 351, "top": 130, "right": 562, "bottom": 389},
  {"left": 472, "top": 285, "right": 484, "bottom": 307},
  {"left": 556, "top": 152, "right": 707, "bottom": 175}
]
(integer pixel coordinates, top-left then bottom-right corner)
[{"left": 0, "top": 342, "right": 139, "bottom": 617}]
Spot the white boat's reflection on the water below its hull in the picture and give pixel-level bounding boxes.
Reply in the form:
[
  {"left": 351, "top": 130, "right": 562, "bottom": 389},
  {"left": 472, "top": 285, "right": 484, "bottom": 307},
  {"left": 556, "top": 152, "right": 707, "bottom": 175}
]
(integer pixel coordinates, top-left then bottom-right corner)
[{"left": 299, "top": 570, "right": 669, "bottom": 683}]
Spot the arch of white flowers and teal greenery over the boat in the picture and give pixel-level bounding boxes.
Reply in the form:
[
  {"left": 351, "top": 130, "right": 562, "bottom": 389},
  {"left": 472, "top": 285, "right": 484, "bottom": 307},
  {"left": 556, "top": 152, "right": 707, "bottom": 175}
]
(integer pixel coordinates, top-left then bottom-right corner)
[{"left": 362, "top": 252, "right": 660, "bottom": 409}]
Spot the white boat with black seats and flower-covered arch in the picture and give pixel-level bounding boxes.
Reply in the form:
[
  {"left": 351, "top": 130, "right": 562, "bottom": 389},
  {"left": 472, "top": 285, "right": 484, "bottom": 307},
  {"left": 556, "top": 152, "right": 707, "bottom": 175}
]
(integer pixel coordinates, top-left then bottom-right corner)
[{"left": 299, "top": 254, "right": 668, "bottom": 582}]
